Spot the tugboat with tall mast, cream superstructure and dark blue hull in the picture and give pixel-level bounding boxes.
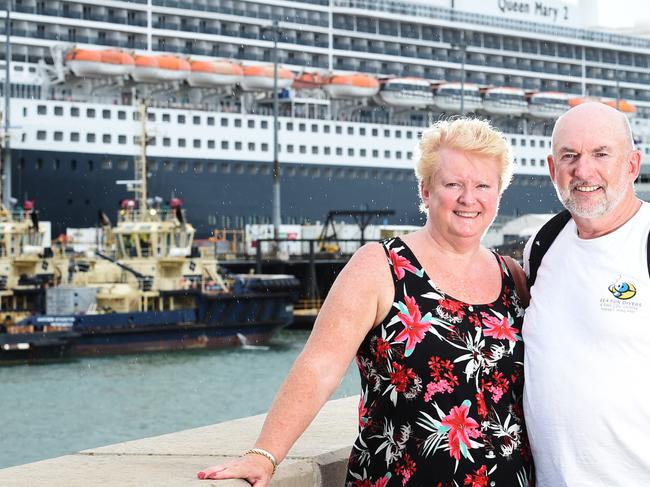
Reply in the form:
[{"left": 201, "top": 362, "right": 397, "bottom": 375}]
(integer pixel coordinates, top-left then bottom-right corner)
[{"left": 0, "top": 104, "right": 299, "bottom": 361}]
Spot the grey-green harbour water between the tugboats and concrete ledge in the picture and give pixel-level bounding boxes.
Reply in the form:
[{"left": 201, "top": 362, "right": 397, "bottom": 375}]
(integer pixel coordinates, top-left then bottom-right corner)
[{"left": 0, "top": 330, "right": 359, "bottom": 468}]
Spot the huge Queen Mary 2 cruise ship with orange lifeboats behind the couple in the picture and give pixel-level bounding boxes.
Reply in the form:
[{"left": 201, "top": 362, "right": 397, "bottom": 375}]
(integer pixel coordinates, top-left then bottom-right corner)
[{"left": 0, "top": 0, "right": 650, "bottom": 236}]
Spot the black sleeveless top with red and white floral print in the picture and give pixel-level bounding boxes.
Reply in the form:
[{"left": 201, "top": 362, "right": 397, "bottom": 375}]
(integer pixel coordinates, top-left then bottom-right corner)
[{"left": 346, "top": 238, "right": 532, "bottom": 487}]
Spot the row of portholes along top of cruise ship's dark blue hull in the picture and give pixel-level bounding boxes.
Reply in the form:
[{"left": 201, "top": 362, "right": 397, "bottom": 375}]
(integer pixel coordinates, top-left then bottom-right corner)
[{"left": 24, "top": 158, "right": 415, "bottom": 181}]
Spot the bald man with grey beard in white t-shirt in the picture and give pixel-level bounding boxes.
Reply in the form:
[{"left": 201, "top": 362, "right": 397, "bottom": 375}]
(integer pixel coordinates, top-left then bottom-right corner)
[{"left": 523, "top": 103, "right": 650, "bottom": 487}]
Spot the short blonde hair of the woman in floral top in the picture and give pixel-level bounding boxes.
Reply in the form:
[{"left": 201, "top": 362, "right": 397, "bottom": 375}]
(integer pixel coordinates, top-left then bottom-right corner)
[{"left": 414, "top": 118, "right": 514, "bottom": 208}]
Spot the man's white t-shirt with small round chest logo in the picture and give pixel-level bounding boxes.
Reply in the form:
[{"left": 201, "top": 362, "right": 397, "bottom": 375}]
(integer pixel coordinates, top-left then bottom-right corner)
[{"left": 523, "top": 203, "right": 650, "bottom": 487}]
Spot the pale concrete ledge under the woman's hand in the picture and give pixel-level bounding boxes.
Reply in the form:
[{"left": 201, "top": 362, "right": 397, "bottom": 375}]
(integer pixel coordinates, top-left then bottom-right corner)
[{"left": 0, "top": 396, "right": 359, "bottom": 487}]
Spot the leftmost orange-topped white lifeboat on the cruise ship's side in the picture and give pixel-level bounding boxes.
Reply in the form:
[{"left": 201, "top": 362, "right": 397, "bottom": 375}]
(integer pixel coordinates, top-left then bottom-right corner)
[{"left": 65, "top": 49, "right": 135, "bottom": 77}]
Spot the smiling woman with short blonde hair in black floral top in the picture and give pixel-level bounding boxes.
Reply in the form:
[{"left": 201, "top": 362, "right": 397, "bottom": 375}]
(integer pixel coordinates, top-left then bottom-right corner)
[{"left": 199, "top": 119, "right": 532, "bottom": 487}]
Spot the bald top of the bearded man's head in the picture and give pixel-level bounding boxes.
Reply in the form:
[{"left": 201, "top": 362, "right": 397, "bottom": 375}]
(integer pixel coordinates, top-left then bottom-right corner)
[{"left": 552, "top": 102, "right": 634, "bottom": 152}]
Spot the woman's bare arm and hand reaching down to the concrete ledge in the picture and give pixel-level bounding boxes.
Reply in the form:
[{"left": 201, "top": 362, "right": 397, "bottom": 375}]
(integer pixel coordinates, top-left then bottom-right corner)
[{"left": 199, "top": 244, "right": 394, "bottom": 487}]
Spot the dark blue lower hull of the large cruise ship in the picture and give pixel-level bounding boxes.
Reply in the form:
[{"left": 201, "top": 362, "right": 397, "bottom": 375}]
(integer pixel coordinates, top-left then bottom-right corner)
[{"left": 12, "top": 150, "right": 560, "bottom": 236}]
